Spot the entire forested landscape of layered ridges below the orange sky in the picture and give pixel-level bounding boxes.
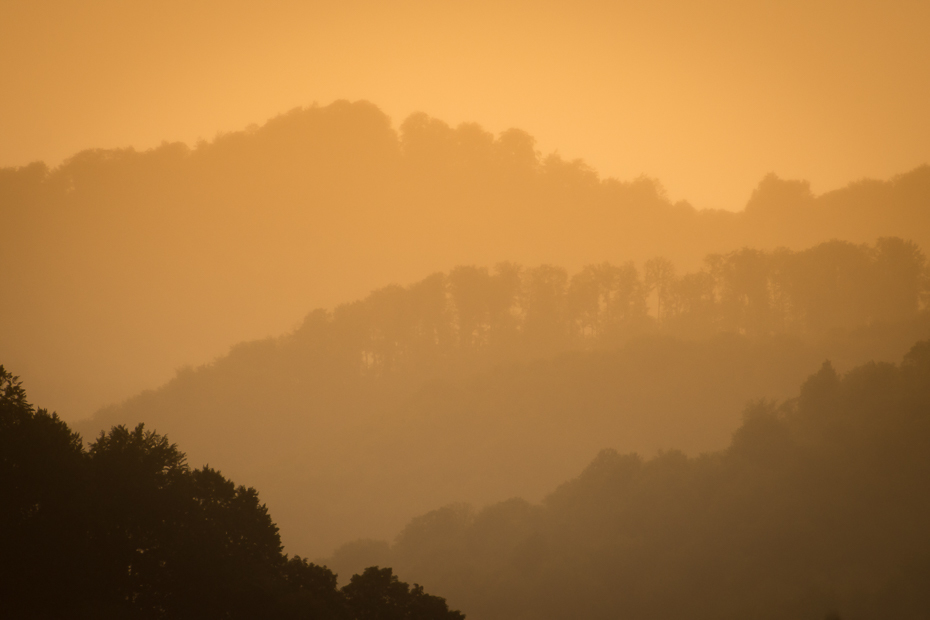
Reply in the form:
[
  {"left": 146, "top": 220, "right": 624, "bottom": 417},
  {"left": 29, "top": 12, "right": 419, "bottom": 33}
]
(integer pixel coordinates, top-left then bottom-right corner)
[{"left": 0, "top": 101, "right": 930, "bottom": 620}]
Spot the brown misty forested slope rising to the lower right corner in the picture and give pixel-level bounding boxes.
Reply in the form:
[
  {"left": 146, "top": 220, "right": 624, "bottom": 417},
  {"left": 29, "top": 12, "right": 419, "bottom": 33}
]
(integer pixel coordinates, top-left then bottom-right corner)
[{"left": 327, "top": 341, "right": 930, "bottom": 620}]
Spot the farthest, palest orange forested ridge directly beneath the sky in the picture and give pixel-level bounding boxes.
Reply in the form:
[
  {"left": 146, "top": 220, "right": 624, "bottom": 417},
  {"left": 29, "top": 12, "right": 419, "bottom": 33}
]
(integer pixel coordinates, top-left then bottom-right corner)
[{"left": 0, "top": 101, "right": 930, "bottom": 419}]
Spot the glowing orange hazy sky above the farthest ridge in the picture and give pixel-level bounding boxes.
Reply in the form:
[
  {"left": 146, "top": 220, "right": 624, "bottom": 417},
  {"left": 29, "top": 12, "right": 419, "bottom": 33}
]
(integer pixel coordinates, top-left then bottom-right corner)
[{"left": 0, "top": 0, "right": 930, "bottom": 209}]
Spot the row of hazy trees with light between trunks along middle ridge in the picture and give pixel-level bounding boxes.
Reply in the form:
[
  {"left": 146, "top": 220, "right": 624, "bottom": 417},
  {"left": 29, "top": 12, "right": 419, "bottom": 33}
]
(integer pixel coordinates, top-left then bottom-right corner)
[{"left": 294, "top": 237, "right": 930, "bottom": 376}]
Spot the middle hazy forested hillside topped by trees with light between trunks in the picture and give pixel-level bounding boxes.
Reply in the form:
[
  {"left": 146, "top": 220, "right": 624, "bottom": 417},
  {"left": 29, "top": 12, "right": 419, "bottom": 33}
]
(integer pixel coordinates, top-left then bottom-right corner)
[{"left": 78, "top": 238, "right": 930, "bottom": 556}]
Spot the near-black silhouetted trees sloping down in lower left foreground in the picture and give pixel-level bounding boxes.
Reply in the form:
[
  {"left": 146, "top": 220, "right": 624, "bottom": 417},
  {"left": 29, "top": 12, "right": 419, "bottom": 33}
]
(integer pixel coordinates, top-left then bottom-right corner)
[{"left": 0, "top": 366, "right": 464, "bottom": 620}]
